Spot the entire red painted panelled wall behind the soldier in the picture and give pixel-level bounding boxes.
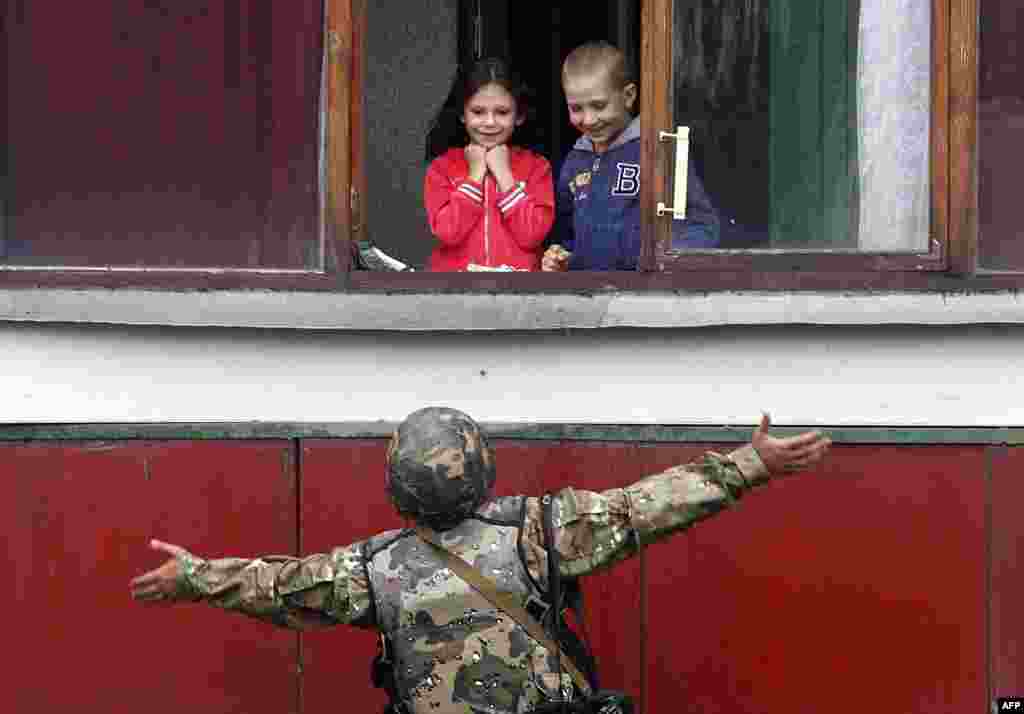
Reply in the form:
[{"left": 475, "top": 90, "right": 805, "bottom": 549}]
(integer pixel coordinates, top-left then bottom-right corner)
[{"left": 0, "top": 439, "right": 1011, "bottom": 714}]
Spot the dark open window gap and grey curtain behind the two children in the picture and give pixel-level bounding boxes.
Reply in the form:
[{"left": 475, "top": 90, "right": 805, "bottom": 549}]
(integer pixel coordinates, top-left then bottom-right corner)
[{"left": 354, "top": 0, "right": 640, "bottom": 274}]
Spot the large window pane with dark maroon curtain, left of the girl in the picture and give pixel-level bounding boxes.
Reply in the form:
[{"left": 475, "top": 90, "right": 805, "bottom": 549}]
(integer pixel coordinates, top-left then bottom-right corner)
[{"left": 0, "top": 0, "right": 324, "bottom": 269}]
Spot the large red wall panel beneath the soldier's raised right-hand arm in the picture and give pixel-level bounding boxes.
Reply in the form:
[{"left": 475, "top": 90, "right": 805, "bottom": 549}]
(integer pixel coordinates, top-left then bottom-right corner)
[{"left": 646, "top": 447, "right": 986, "bottom": 714}]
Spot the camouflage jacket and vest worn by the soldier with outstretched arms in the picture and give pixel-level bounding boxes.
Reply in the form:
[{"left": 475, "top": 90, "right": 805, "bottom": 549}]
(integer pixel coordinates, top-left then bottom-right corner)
[{"left": 181, "top": 446, "right": 767, "bottom": 714}]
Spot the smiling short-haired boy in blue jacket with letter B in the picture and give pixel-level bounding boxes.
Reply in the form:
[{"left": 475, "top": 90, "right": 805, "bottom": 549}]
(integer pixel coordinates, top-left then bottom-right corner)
[{"left": 542, "top": 42, "right": 719, "bottom": 270}]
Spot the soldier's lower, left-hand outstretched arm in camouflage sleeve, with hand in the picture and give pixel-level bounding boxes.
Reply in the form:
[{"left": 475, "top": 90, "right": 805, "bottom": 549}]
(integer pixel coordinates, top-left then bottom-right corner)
[{"left": 130, "top": 540, "right": 374, "bottom": 629}]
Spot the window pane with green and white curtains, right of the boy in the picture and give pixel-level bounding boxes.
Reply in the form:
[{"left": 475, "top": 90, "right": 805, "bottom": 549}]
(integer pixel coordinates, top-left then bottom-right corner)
[{"left": 658, "top": 0, "right": 932, "bottom": 252}]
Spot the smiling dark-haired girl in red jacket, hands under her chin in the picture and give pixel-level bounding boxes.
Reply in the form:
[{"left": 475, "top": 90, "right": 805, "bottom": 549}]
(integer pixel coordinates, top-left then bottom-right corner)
[{"left": 423, "top": 59, "right": 555, "bottom": 270}]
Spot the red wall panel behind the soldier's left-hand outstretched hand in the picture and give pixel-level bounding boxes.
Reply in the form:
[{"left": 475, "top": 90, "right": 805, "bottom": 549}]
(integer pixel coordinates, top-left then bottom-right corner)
[{"left": 0, "top": 442, "right": 298, "bottom": 714}]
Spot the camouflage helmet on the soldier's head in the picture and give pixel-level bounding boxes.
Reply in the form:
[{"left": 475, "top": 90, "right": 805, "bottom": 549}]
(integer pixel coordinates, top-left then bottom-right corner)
[{"left": 385, "top": 407, "right": 495, "bottom": 531}]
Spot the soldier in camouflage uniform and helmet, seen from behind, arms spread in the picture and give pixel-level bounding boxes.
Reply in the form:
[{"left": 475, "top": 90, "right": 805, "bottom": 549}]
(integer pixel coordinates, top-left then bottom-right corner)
[{"left": 131, "top": 408, "right": 829, "bottom": 714}]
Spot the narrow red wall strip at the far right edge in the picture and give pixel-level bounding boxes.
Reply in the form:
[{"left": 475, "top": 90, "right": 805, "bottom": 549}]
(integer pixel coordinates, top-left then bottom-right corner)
[{"left": 990, "top": 448, "right": 1024, "bottom": 697}]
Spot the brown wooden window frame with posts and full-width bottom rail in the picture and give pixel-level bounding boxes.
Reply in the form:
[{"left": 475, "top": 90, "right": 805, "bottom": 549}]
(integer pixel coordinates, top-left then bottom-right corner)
[{"left": 0, "top": 0, "right": 1024, "bottom": 294}]
